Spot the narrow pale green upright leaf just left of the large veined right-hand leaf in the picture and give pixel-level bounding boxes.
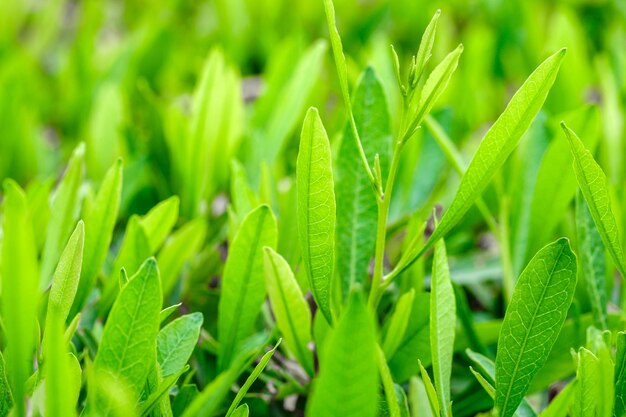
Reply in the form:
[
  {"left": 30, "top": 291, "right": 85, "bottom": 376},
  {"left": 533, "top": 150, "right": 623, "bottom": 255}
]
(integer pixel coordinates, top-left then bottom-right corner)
[{"left": 430, "top": 239, "right": 456, "bottom": 417}]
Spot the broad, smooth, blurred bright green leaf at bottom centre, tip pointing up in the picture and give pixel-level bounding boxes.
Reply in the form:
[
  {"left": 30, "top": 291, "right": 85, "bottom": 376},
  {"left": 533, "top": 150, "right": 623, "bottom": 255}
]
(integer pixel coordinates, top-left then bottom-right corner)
[{"left": 307, "top": 292, "right": 378, "bottom": 417}]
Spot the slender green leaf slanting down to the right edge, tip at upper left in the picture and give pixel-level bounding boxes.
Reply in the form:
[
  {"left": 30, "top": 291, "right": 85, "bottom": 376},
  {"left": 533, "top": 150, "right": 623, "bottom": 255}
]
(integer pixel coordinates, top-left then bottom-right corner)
[{"left": 561, "top": 123, "right": 626, "bottom": 278}]
